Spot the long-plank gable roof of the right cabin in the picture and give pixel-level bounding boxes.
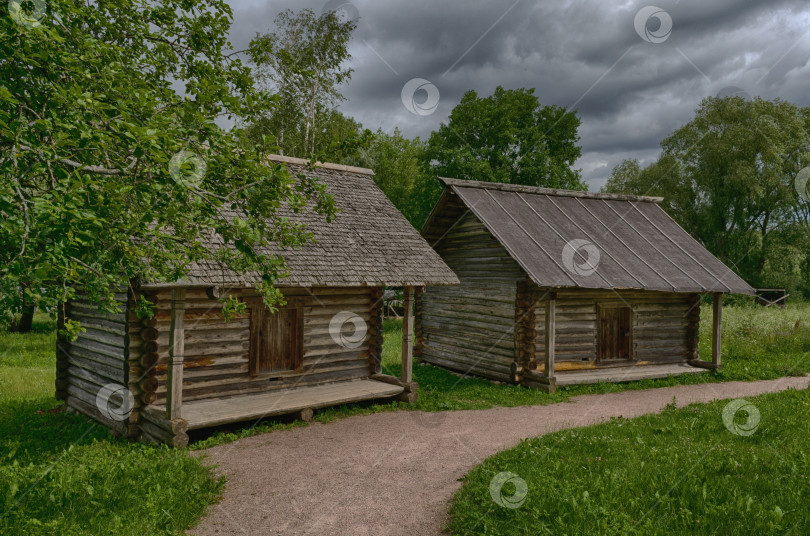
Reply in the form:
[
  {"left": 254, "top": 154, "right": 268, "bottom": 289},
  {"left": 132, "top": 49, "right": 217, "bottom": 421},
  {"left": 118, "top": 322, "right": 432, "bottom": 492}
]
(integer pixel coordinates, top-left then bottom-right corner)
[{"left": 422, "top": 179, "right": 755, "bottom": 294}]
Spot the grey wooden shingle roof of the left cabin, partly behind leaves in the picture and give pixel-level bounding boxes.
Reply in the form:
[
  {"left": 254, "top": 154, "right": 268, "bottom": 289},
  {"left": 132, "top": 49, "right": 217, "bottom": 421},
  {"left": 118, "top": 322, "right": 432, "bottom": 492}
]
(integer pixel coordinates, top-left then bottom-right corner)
[{"left": 146, "top": 156, "right": 458, "bottom": 287}]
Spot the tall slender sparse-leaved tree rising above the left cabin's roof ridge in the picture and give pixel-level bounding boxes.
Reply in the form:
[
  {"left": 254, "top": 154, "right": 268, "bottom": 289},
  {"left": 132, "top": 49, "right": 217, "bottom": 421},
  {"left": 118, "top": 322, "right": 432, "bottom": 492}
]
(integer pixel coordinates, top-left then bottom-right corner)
[{"left": 249, "top": 9, "right": 355, "bottom": 158}]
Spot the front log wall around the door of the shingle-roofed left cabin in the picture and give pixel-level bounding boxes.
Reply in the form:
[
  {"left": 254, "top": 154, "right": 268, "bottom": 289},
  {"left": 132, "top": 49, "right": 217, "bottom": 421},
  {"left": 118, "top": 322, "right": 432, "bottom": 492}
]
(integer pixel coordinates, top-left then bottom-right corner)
[{"left": 140, "top": 287, "right": 374, "bottom": 405}]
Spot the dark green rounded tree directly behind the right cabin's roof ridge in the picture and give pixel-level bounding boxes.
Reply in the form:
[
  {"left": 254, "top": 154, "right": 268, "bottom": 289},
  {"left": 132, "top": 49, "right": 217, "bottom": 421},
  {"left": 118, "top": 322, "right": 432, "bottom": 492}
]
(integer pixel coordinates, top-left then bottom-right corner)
[{"left": 427, "top": 86, "right": 586, "bottom": 190}]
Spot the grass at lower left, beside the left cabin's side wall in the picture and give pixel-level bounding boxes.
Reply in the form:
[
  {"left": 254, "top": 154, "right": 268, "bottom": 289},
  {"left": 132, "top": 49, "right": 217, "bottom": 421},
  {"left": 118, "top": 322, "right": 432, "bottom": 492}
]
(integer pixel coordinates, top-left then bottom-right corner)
[{"left": 0, "top": 317, "right": 223, "bottom": 536}]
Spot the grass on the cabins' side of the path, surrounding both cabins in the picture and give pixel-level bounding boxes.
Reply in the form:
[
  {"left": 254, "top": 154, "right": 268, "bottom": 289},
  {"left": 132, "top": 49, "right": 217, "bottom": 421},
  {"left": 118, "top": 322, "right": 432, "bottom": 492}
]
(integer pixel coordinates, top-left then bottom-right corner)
[{"left": 0, "top": 304, "right": 810, "bottom": 535}]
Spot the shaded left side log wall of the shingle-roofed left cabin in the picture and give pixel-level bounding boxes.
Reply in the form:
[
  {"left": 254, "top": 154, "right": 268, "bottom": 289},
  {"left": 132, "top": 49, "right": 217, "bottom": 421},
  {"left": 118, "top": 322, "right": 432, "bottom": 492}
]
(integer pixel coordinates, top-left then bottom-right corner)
[{"left": 62, "top": 292, "right": 133, "bottom": 437}]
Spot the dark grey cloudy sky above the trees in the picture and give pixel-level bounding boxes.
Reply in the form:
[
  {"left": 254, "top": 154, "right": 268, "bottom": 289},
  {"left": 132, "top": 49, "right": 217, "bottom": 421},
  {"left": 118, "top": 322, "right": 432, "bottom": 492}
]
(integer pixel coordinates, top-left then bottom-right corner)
[{"left": 224, "top": 0, "right": 810, "bottom": 190}]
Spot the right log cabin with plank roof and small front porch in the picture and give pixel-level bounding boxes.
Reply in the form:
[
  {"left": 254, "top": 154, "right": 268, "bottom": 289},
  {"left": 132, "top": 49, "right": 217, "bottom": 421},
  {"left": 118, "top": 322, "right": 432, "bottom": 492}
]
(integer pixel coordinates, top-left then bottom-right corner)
[{"left": 415, "top": 179, "right": 755, "bottom": 391}]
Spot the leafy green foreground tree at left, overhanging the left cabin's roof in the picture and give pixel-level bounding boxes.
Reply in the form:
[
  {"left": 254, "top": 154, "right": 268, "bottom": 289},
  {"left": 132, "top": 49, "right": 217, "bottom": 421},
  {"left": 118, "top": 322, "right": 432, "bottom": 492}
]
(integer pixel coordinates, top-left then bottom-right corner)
[{"left": 0, "top": 0, "right": 335, "bottom": 336}]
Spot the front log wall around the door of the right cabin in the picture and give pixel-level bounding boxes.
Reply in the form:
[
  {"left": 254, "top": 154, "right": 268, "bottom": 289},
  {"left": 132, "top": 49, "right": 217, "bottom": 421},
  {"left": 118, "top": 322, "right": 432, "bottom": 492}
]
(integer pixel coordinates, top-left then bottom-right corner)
[{"left": 535, "top": 289, "right": 700, "bottom": 372}]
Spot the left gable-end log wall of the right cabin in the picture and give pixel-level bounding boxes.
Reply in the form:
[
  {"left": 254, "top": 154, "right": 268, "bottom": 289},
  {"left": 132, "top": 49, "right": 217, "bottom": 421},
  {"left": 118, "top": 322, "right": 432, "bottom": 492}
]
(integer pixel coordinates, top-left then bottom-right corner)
[{"left": 416, "top": 212, "right": 525, "bottom": 381}]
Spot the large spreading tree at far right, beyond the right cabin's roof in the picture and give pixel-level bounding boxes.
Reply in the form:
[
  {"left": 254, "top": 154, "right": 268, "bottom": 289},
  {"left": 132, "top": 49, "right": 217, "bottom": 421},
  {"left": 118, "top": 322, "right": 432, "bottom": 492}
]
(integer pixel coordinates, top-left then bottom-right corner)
[{"left": 606, "top": 97, "right": 810, "bottom": 287}]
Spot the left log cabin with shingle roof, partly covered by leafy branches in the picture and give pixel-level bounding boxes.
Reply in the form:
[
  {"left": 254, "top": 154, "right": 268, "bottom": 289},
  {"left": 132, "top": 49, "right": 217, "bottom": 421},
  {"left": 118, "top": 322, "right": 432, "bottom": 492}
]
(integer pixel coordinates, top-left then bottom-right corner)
[{"left": 56, "top": 156, "right": 458, "bottom": 446}]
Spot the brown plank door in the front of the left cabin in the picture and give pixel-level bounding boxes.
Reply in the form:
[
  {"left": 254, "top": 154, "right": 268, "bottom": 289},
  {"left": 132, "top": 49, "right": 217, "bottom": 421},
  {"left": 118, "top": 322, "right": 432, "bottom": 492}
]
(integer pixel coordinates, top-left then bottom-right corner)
[{"left": 249, "top": 302, "right": 304, "bottom": 376}]
